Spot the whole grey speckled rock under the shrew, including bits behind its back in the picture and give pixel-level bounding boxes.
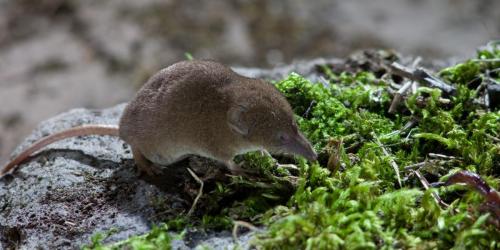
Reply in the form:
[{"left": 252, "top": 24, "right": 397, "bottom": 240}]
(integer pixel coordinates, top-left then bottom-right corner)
[{"left": 0, "top": 59, "right": 338, "bottom": 249}]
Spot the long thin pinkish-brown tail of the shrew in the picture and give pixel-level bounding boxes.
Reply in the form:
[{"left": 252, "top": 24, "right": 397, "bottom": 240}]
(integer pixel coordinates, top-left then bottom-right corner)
[{"left": 0, "top": 124, "right": 118, "bottom": 179}]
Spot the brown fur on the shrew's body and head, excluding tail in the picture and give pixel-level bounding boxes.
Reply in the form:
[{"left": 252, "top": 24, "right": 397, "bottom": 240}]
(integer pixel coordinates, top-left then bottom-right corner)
[{"left": 120, "top": 61, "right": 315, "bottom": 169}]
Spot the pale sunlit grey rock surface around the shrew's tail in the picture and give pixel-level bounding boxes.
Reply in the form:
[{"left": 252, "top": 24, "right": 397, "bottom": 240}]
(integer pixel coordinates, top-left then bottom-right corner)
[{"left": 0, "top": 104, "right": 148, "bottom": 249}]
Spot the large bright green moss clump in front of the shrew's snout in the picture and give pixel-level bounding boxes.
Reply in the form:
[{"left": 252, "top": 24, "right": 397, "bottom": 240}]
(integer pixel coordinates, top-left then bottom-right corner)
[{"left": 255, "top": 44, "right": 500, "bottom": 249}]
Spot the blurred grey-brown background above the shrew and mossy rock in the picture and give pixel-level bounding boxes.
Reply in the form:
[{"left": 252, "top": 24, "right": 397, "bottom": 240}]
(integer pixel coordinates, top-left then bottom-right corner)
[{"left": 0, "top": 0, "right": 500, "bottom": 160}]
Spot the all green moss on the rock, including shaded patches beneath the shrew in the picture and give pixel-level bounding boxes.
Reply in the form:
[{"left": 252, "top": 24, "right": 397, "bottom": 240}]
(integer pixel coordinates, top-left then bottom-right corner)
[{"left": 84, "top": 44, "right": 500, "bottom": 249}]
